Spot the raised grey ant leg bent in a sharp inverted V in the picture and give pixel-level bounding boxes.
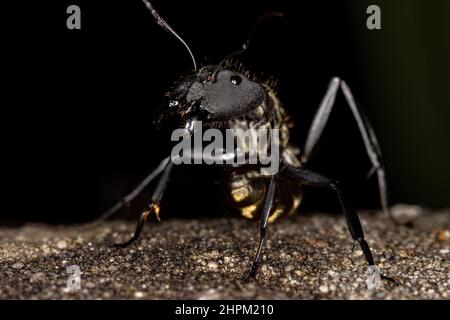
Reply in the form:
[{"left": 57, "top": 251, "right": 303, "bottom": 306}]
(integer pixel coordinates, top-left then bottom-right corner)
[{"left": 301, "top": 77, "right": 395, "bottom": 222}]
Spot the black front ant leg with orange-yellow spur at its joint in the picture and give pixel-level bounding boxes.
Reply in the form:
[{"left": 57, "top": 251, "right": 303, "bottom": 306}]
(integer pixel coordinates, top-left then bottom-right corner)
[{"left": 115, "top": 161, "right": 173, "bottom": 247}]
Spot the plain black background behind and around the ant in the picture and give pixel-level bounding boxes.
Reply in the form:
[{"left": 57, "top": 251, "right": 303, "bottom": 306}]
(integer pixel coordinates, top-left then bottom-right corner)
[{"left": 0, "top": 0, "right": 450, "bottom": 222}]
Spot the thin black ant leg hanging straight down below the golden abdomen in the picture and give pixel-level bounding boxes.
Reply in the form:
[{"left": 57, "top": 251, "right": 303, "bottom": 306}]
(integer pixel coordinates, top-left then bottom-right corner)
[{"left": 249, "top": 174, "right": 277, "bottom": 279}]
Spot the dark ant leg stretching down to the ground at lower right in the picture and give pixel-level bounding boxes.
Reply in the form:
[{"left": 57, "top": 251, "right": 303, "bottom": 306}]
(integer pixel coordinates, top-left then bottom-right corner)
[{"left": 285, "top": 165, "right": 393, "bottom": 281}]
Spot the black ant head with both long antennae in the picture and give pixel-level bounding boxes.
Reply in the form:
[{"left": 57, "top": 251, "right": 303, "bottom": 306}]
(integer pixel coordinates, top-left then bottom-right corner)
[{"left": 143, "top": 0, "right": 283, "bottom": 122}]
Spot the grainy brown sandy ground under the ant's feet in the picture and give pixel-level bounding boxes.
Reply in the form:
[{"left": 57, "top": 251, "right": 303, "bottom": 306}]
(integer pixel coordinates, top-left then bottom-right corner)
[{"left": 0, "top": 211, "right": 450, "bottom": 299}]
